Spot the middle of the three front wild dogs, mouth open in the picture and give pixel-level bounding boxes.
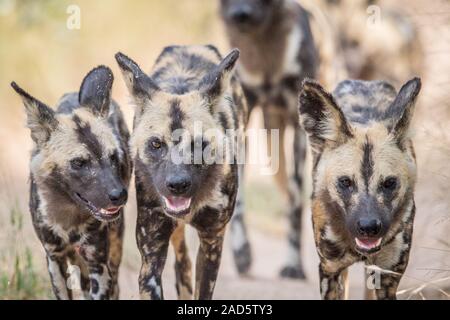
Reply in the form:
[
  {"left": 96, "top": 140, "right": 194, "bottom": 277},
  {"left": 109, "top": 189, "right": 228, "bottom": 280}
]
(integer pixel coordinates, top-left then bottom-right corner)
[{"left": 116, "top": 46, "right": 247, "bottom": 299}]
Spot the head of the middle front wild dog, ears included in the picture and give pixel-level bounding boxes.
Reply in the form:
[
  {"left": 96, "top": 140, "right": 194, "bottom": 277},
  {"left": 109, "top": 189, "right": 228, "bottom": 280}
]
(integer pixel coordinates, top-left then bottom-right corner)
[{"left": 116, "top": 47, "right": 239, "bottom": 217}]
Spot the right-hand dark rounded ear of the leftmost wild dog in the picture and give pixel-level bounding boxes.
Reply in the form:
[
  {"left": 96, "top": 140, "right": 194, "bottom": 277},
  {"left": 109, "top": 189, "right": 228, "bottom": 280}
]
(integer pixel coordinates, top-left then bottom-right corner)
[{"left": 78, "top": 66, "right": 114, "bottom": 117}]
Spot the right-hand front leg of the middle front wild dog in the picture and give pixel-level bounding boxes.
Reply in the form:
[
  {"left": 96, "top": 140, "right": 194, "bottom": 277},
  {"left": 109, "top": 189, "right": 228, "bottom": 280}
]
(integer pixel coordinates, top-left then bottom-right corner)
[{"left": 195, "top": 228, "right": 225, "bottom": 300}]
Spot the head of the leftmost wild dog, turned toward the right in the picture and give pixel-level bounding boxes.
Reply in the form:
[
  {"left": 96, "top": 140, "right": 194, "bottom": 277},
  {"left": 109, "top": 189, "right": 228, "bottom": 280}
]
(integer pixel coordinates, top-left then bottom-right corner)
[{"left": 11, "top": 66, "right": 129, "bottom": 220}]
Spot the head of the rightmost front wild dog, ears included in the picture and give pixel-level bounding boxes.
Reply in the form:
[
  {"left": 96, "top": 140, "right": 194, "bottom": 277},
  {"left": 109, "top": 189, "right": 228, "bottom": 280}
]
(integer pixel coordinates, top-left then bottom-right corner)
[{"left": 300, "top": 78, "right": 421, "bottom": 253}]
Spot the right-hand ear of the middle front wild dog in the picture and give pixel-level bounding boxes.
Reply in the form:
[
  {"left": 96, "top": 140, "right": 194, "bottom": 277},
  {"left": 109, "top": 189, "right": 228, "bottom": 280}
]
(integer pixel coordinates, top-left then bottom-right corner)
[{"left": 199, "top": 49, "right": 239, "bottom": 101}]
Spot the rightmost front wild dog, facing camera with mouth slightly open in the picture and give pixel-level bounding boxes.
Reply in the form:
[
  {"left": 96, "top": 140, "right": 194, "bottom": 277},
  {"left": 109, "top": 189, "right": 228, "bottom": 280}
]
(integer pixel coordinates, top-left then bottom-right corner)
[{"left": 299, "top": 78, "right": 421, "bottom": 299}]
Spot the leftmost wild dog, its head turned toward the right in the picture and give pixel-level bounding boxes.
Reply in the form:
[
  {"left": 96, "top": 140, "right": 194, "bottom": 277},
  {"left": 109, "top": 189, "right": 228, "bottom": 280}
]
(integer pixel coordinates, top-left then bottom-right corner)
[{"left": 11, "top": 66, "right": 132, "bottom": 299}]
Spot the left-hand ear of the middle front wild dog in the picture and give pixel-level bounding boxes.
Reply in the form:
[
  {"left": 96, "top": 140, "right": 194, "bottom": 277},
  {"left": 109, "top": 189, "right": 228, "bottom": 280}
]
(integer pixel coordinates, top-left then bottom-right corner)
[{"left": 115, "top": 52, "right": 159, "bottom": 100}]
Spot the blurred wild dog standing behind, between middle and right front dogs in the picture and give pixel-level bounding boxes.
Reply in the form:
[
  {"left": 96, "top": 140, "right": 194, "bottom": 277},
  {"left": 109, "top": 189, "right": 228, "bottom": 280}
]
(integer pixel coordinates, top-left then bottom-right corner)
[{"left": 221, "top": 0, "right": 318, "bottom": 278}]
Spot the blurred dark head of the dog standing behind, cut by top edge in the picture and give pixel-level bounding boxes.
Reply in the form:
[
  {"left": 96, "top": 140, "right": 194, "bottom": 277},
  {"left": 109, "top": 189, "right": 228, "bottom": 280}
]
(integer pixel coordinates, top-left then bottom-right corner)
[{"left": 220, "top": 0, "right": 285, "bottom": 32}]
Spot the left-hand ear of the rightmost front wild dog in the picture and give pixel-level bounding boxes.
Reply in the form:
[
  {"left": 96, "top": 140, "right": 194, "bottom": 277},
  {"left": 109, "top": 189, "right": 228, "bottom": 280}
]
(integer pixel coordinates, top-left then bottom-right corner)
[{"left": 299, "top": 79, "right": 353, "bottom": 151}]
